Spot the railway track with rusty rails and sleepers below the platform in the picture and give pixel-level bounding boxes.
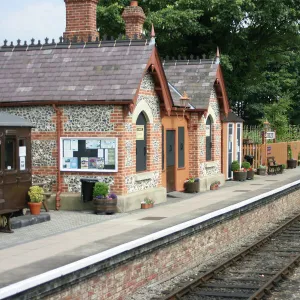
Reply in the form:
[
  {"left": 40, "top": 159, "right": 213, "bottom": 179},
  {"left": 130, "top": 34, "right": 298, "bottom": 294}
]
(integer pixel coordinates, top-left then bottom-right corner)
[{"left": 161, "top": 214, "right": 300, "bottom": 300}]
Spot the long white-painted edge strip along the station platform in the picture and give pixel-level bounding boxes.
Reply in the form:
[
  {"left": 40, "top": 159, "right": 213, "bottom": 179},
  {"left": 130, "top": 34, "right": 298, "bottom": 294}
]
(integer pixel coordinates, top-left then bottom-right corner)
[{"left": 0, "top": 180, "right": 300, "bottom": 299}]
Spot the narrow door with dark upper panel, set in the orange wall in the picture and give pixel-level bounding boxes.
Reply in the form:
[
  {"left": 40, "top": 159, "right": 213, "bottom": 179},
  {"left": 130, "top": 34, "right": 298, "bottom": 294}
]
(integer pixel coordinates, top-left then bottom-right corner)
[{"left": 166, "top": 130, "right": 175, "bottom": 193}]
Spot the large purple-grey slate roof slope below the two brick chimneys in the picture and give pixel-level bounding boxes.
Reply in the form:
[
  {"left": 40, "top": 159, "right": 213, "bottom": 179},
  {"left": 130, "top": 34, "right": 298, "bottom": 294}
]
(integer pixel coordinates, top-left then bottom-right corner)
[{"left": 0, "top": 40, "right": 153, "bottom": 103}]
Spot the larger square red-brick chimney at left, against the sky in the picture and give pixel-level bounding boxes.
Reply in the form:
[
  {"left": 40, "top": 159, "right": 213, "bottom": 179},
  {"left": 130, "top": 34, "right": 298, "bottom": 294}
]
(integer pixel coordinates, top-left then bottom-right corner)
[{"left": 64, "top": 0, "right": 99, "bottom": 42}]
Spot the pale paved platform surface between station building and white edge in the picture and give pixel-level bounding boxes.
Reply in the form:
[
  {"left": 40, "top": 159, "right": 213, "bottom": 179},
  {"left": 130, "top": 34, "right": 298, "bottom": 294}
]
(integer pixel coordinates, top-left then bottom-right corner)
[{"left": 0, "top": 168, "right": 300, "bottom": 287}]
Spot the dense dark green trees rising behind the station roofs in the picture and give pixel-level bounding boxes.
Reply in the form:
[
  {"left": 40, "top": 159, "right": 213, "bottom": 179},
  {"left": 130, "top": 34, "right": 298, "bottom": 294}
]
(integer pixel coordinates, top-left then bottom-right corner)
[{"left": 97, "top": 0, "right": 300, "bottom": 124}]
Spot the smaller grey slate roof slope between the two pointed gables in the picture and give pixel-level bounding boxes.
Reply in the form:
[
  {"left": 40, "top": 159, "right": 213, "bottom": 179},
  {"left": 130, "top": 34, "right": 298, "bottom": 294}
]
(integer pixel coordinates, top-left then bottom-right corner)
[{"left": 163, "top": 59, "right": 219, "bottom": 109}]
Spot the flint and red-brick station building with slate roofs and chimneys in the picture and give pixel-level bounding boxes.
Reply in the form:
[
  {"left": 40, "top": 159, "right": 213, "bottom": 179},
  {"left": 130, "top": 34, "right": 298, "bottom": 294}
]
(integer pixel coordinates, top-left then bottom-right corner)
[{"left": 0, "top": 0, "right": 242, "bottom": 211}]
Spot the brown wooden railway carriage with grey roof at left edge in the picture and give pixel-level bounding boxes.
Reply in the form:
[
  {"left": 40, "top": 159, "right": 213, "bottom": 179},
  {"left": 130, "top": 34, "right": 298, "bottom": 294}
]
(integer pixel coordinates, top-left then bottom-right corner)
[{"left": 0, "top": 112, "right": 34, "bottom": 231}]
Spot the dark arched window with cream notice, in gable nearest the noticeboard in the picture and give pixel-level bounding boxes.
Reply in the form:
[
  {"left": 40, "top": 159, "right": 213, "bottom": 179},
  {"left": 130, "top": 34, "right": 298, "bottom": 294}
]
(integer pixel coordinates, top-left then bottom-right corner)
[{"left": 136, "top": 112, "right": 147, "bottom": 172}]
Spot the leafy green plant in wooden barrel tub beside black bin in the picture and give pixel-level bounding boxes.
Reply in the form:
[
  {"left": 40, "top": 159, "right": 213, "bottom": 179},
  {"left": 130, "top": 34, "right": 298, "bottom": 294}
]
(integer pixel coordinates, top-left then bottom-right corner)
[{"left": 93, "top": 182, "right": 118, "bottom": 214}]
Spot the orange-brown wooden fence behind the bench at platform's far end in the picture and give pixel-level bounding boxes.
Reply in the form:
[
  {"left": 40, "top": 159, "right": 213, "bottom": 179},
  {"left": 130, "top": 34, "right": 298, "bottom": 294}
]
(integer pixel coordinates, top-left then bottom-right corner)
[{"left": 243, "top": 141, "right": 300, "bottom": 168}]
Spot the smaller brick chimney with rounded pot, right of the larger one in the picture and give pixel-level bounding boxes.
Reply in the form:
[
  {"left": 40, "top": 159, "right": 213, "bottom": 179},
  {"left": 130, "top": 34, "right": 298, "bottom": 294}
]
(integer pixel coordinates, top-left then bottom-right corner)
[{"left": 122, "top": 1, "right": 146, "bottom": 39}]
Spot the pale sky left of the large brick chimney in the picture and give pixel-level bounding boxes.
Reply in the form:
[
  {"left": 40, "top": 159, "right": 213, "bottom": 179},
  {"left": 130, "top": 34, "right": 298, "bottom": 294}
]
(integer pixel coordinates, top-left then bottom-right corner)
[{"left": 0, "top": 0, "right": 66, "bottom": 46}]
